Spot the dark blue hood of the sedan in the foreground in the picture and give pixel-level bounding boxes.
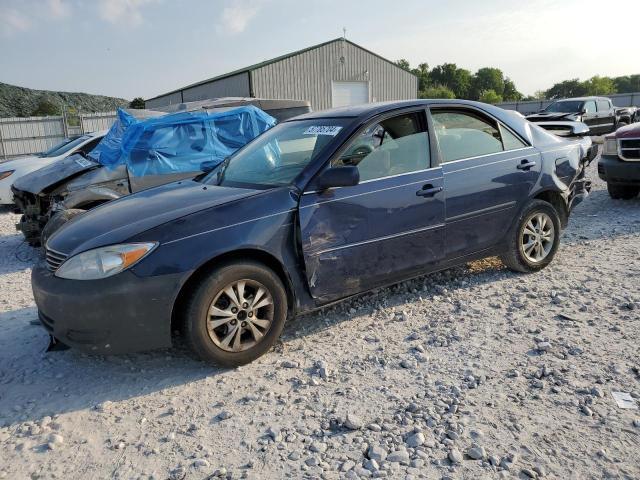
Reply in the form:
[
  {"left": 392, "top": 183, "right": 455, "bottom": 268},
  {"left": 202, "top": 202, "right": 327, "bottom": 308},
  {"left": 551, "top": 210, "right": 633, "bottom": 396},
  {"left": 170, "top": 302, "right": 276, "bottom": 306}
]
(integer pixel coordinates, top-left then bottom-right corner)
[{"left": 47, "top": 180, "right": 261, "bottom": 255}]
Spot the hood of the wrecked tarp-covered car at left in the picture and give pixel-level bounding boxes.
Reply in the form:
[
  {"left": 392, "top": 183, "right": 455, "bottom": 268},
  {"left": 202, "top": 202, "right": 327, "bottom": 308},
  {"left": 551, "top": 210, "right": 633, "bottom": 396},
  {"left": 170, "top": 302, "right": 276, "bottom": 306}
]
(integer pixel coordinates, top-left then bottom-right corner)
[{"left": 13, "top": 154, "right": 101, "bottom": 195}]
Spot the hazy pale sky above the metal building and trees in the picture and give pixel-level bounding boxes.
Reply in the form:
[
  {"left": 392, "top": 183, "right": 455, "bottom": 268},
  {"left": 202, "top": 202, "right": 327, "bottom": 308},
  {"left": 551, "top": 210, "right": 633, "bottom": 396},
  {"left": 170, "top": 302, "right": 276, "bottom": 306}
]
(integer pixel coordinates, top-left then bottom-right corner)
[{"left": 0, "top": 0, "right": 640, "bottom": 99}]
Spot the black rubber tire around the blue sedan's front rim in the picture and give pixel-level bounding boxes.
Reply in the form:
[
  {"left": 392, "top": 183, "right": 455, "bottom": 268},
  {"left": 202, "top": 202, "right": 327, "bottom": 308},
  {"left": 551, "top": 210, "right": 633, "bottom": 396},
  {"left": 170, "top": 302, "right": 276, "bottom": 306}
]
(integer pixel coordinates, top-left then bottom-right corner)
[{"left": 182, "top": 261, "right": 288, "bottom": 367}]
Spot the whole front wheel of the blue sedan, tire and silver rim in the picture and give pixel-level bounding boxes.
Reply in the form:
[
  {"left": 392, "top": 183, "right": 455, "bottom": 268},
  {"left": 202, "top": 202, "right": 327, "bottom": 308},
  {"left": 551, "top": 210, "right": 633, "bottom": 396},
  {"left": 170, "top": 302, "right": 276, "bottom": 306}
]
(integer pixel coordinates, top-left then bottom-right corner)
[{"left": 183, "top": 262, "right": 288, "bottom": 367}]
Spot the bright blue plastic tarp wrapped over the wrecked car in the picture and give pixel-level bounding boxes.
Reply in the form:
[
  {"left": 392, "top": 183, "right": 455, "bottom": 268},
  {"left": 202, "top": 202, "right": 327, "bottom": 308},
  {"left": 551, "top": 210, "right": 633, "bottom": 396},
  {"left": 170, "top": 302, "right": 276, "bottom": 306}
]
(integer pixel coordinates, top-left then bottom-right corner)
[{"left": 91, "top": 105, "right": 276, "bottom": 177}]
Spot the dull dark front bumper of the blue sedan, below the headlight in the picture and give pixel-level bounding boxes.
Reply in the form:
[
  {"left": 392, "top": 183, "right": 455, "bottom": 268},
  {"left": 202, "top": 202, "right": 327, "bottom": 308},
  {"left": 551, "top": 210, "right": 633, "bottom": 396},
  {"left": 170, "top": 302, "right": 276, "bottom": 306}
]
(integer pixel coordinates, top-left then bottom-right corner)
[{"left": 31, "top": 263, "right": 182, "bottom": 354}]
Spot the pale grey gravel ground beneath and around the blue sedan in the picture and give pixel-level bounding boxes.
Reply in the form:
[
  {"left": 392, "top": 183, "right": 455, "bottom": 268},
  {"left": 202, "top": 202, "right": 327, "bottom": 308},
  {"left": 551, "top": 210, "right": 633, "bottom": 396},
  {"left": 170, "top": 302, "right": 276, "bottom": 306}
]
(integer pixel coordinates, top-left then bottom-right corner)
[{"left": 0, "top": 162, "right": 640, "bottom": 479}]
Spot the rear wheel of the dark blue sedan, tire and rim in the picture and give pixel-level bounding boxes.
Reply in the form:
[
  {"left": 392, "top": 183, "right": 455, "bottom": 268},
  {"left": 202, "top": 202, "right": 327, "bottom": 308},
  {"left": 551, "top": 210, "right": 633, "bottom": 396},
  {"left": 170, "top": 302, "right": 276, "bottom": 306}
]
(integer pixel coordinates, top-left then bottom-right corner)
[{"left": 501, "top": 200, "right": 560, "bottom": 272}]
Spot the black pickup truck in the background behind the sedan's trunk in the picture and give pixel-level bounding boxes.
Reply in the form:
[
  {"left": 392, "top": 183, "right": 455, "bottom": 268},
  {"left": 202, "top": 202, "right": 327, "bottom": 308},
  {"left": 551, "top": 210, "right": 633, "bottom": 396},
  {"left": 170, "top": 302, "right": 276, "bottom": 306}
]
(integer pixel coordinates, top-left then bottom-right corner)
[{"left": 526, "top": 97, "right": 617, "bottom": 135}]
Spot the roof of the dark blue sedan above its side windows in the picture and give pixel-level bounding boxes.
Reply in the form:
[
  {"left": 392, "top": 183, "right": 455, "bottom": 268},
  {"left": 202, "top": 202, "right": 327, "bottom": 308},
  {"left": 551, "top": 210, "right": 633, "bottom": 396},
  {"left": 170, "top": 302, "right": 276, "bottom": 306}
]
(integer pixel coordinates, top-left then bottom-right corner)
[{"left": 287, "top": 99, "right": 499, "bottom": 121}]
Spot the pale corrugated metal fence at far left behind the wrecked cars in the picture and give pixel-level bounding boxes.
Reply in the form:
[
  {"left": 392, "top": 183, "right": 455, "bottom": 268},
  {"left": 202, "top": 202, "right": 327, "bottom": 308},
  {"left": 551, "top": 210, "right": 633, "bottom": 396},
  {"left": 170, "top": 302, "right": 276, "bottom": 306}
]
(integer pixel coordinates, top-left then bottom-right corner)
[{"left": 0, "top": 112, "right": 116, "bottom": 161}]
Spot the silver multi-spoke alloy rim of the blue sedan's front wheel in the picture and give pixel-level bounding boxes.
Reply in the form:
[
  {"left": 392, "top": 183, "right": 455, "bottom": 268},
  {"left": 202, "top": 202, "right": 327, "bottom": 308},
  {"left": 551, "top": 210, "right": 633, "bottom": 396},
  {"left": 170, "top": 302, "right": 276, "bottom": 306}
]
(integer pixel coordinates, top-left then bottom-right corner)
[{"left": 207, "top": 280, "right": 275, "bottom": 352}]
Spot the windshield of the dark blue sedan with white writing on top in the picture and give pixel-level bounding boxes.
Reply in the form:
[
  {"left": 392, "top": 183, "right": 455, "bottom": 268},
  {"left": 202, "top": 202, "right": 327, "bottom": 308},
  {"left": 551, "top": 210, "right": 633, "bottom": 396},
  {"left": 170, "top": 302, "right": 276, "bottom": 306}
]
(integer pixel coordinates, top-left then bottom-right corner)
[{"left": 203, "top": 118, "right": 348, "bottom": 187}]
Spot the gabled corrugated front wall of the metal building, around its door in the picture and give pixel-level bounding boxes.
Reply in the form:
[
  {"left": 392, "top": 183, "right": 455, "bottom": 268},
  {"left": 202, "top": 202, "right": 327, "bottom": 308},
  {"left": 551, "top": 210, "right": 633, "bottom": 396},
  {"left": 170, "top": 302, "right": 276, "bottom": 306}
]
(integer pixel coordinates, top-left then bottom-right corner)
[{"left": 251, "top": 41, "right": 418, "bottom": 110}]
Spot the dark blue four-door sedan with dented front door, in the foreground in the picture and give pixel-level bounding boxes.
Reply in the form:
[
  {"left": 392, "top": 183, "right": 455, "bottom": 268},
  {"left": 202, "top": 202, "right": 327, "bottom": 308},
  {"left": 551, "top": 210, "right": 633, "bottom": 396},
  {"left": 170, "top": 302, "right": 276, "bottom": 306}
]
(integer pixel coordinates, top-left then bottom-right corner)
[{"left": 32, "top": 100, "right": 593, "bottom": 366}]
